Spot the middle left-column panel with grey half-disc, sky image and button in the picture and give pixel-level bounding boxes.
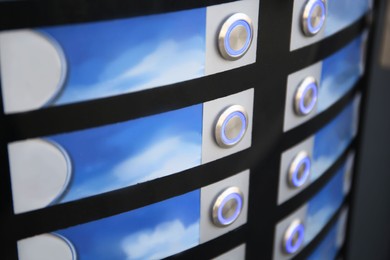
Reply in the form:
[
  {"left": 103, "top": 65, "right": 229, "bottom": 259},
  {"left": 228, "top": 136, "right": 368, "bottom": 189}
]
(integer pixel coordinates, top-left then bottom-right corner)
[{"left": 8, "top": 89, "right": 254, "bottom": 213}]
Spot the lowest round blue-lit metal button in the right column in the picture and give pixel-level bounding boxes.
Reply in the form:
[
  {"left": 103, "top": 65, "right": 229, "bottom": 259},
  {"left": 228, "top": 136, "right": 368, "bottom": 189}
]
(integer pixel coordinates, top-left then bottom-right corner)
[{"left": 282, "top": 219, "right": 305, "bottom": 255}]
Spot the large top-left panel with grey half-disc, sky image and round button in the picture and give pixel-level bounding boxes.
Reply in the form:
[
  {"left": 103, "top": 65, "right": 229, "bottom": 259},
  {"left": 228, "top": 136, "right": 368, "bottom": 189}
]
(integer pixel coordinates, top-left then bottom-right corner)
[{"left": 0, "top": 0, "right": 259, "bottom": 113}]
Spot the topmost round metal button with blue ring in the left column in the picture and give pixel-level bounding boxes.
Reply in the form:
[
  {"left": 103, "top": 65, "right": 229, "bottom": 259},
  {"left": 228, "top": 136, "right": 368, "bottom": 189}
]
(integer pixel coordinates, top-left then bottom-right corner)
[{"left": 218, "top": 13, "right": 253, "bottom": 60}]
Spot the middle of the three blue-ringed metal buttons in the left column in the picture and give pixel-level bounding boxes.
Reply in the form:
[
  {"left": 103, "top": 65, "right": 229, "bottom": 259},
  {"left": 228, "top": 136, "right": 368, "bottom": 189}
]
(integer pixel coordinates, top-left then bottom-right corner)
[{"left": 215, "top": 105, "right": 248, "bottom": 148}]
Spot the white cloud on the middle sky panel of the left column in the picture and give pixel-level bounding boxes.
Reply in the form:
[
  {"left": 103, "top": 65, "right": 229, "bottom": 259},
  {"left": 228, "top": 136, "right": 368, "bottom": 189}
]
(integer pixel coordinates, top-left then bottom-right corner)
[{"left": 63, "top": 133, "right": 201, "bottom": 201}]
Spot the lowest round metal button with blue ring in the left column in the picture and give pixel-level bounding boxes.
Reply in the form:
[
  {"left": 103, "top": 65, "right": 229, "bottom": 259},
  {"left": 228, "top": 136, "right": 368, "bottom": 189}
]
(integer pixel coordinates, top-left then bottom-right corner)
[{"left": 212, "top": 187, "right": 244, "bottom": 227}]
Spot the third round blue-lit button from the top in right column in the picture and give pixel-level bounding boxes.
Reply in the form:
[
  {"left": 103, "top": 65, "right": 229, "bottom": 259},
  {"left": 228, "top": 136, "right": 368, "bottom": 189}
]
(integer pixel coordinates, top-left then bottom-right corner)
[{"left": 288, "top": 151, "right": 311, "bottom": 188}]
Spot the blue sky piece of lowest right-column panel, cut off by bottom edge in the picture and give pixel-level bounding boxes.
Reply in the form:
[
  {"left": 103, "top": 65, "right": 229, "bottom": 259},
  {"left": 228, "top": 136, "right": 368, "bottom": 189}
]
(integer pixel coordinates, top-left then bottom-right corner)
[{"left": 307, "top": 219, "right": 339, "bottom": 260}]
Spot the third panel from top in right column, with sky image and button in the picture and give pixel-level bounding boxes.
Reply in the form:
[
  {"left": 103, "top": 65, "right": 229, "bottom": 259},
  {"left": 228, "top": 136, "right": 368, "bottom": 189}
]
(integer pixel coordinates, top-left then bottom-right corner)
[{"left": 278, "top": 95, "right": 360, "bottom": 205}]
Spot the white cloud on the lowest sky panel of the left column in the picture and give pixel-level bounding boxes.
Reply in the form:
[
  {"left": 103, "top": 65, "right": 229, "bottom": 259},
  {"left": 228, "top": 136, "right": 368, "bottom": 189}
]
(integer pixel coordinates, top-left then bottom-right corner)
[{"left": 121, "top": 219, "right": 199, "bottom": 259}]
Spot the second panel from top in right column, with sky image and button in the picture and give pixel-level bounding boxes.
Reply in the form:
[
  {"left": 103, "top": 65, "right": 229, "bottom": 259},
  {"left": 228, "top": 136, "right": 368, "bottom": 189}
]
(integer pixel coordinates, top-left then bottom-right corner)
[{"left": 283, "top": 32, "right": 367, "bottom": 132}]
